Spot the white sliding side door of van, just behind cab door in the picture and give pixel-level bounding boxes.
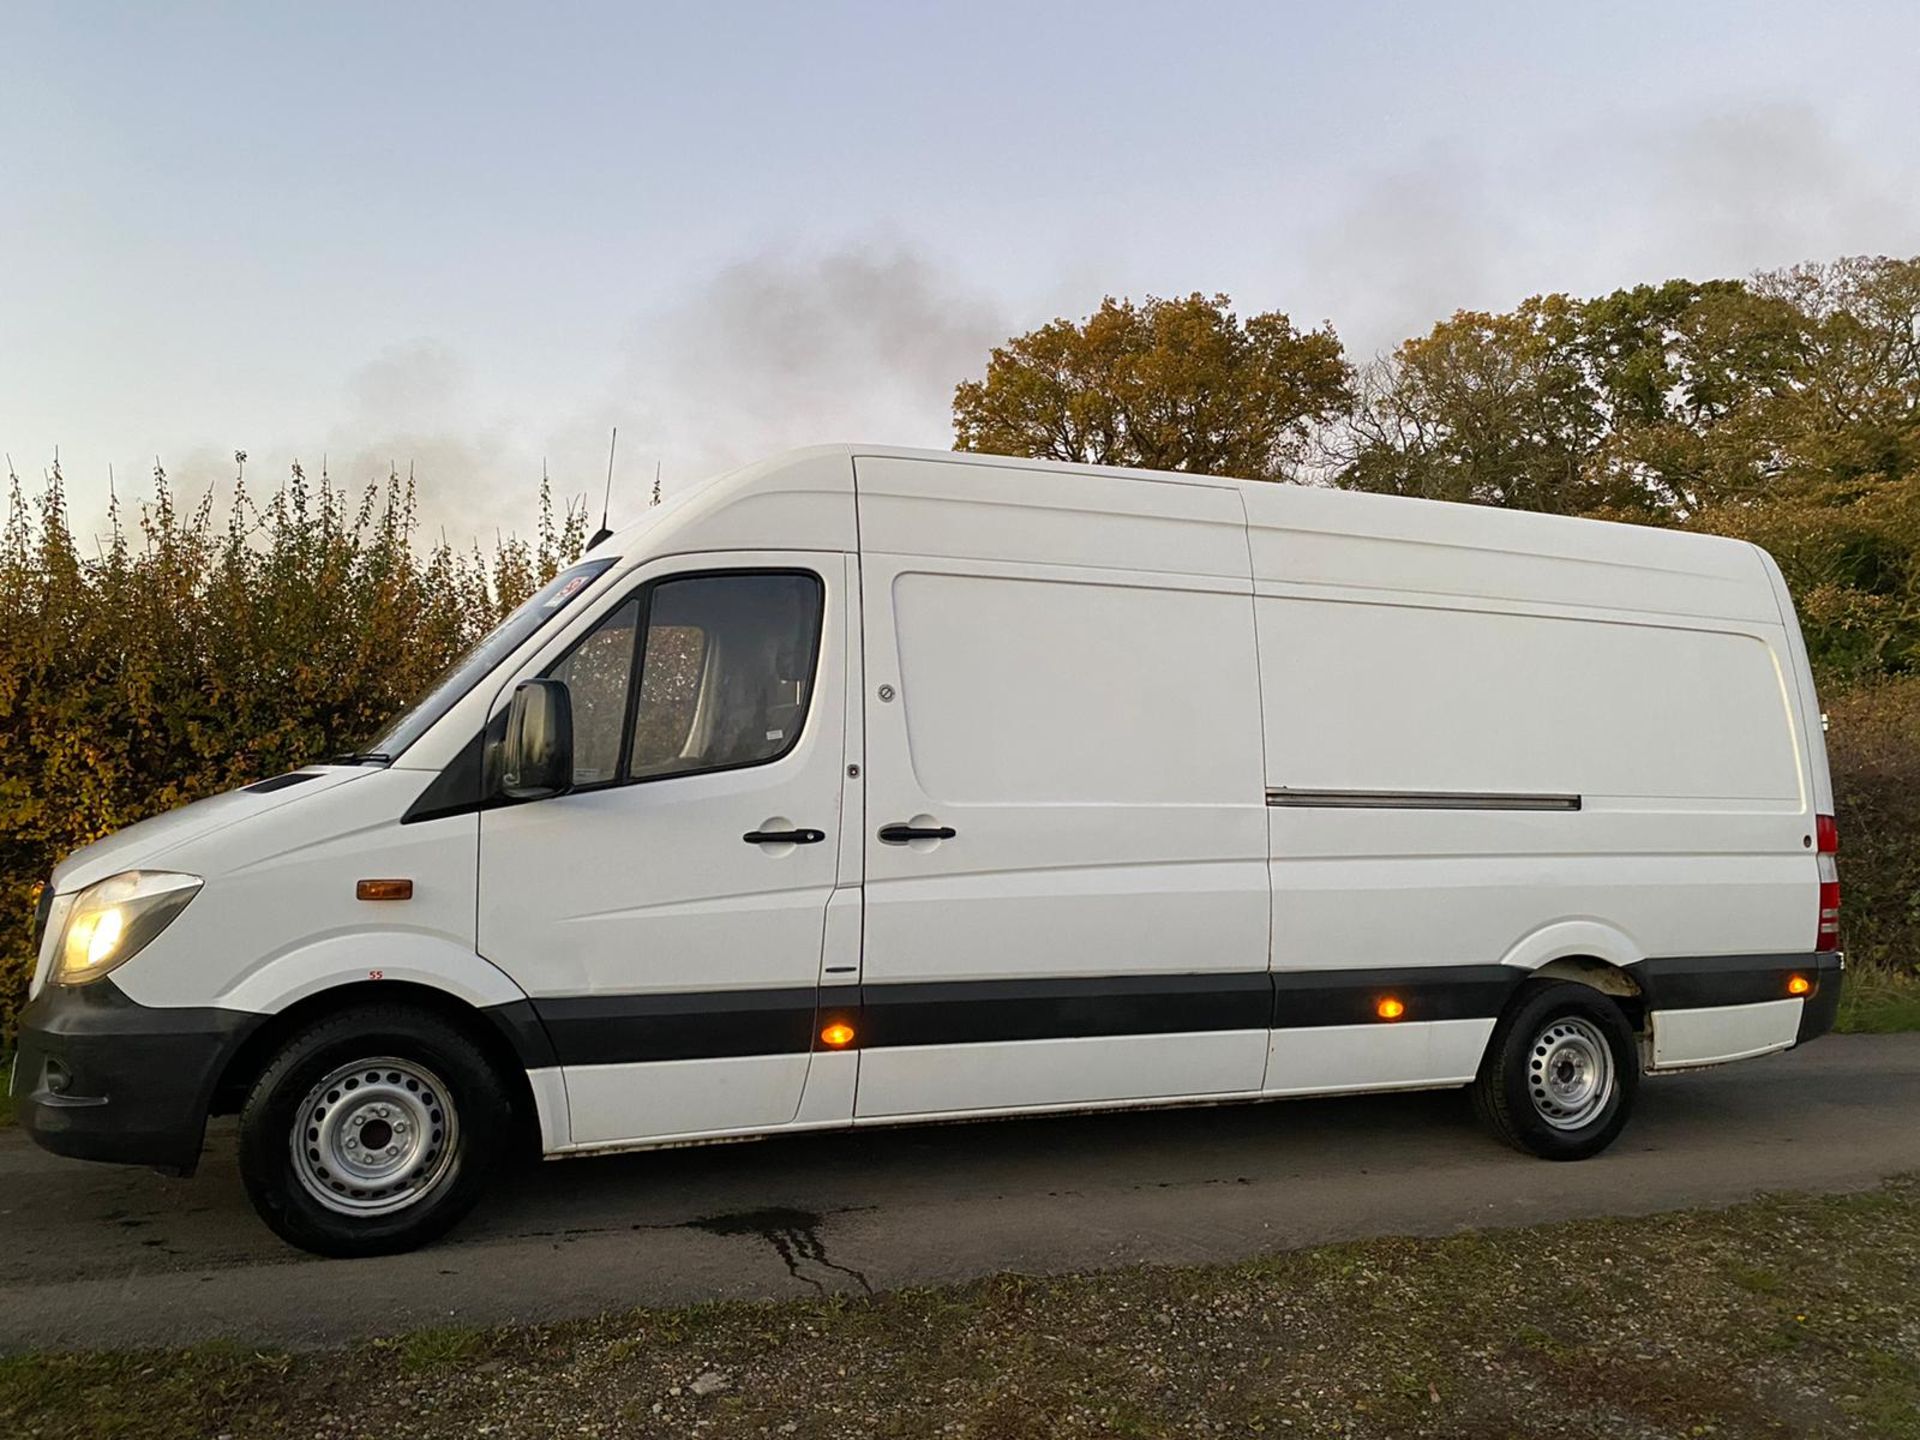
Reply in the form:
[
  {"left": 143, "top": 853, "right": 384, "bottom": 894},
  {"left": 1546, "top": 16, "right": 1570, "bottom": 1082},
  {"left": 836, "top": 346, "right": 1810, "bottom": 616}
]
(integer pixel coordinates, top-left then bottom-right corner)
[{"left": 854, "top": 457, "right": 1269, "bottom": 1117}]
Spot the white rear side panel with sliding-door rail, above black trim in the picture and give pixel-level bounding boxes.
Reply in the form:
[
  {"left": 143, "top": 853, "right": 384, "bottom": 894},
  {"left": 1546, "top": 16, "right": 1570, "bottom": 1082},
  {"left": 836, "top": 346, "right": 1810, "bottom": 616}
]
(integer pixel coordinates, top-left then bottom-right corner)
[{"left": 1242, "top": 486, "right": 1822, "bottom": 1044}]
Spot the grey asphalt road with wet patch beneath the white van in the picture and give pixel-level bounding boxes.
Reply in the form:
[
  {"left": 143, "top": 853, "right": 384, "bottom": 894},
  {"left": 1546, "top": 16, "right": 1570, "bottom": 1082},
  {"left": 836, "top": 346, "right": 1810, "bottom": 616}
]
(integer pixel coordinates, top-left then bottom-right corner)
[{"left": 0, "top": 1035, "right": 1920, "bottom": 1350}]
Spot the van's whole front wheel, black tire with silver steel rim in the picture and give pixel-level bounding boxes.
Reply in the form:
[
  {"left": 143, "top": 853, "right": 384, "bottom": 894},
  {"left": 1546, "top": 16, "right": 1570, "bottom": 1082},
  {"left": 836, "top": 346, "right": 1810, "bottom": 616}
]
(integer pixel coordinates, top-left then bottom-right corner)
[{"left": 240, "top": 1004, "right": 513, "bottom": 1258}]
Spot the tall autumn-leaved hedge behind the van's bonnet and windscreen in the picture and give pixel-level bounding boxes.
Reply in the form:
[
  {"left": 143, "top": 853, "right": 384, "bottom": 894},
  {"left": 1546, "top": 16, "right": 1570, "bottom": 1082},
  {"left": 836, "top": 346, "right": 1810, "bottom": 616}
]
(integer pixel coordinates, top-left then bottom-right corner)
[{"left": 0, "top": 465, "right": 586, "bottom": 1050}]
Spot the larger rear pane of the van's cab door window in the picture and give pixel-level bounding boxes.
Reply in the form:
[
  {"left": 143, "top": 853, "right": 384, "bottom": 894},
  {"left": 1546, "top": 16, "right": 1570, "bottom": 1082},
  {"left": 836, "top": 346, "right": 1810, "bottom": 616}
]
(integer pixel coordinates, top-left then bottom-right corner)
[{"left": 633, "top": 574, "right": 822, "bottom": 780}]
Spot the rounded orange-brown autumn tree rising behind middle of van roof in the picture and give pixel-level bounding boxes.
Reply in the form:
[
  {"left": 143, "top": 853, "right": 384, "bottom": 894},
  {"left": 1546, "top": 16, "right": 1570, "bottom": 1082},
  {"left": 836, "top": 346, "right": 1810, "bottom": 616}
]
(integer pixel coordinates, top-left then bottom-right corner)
[{"left": 954, "top": 292, "right": 1352, "bottom": 480}]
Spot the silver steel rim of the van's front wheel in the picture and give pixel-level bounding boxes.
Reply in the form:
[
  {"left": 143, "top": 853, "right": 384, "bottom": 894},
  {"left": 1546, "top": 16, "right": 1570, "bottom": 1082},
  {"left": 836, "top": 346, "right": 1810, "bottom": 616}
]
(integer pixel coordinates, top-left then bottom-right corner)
[{"left": 290, "top": 1056, "right": 461, "bottom": 1215}]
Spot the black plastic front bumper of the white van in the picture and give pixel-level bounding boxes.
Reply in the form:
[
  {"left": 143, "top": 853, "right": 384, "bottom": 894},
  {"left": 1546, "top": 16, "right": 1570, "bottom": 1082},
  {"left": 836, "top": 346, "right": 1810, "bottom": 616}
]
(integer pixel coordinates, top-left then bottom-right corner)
[{"left": 13, "top": 979, "right": 265, "bottom": 1175}]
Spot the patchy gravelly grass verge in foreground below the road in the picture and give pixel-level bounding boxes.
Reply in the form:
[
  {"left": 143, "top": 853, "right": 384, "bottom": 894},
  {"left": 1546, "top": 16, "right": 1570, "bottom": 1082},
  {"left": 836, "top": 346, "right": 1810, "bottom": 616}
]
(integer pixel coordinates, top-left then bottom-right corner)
[{"left": 0, "top": 1181, "right": 1920, "bottom": 1440}]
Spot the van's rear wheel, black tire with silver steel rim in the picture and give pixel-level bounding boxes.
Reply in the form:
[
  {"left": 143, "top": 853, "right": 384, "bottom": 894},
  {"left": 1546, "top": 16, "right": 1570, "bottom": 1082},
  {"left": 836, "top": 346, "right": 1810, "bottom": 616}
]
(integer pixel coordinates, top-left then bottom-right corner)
[{"left": 1473, "top": 981, "right": 1640, "bottom": 1160}]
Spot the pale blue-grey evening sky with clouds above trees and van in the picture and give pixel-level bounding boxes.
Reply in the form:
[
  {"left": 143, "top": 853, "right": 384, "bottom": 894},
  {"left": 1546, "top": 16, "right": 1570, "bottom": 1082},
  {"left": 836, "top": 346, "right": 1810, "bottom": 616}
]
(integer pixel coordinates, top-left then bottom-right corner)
[{"left": 0, "top": 0, "right": 1920, "bottom": 543}]
